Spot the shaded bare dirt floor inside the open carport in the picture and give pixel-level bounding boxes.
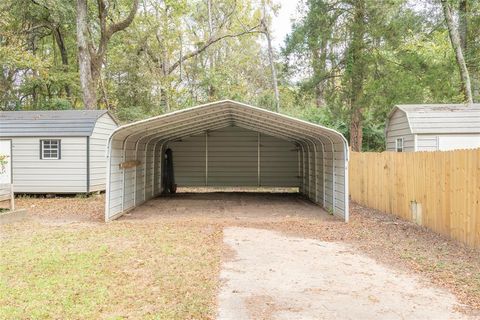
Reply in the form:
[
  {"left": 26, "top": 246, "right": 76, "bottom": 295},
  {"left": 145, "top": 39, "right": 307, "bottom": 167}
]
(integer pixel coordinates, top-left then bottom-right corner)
[{"left": 120, "top": 192, "right": 339, "bottom": 223}]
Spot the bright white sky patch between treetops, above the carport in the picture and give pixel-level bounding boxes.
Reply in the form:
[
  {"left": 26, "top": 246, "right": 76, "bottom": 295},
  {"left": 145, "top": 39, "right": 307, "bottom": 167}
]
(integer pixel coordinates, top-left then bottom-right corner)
[{"left": 272, "top": 0, "right": 299, "bottom": 49}]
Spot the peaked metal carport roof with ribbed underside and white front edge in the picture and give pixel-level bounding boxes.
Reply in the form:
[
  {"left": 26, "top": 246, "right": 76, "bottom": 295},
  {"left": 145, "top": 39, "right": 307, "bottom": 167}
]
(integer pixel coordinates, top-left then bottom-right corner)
[{"left": 106, "top": 100, "right": 348, "bottom": 220}]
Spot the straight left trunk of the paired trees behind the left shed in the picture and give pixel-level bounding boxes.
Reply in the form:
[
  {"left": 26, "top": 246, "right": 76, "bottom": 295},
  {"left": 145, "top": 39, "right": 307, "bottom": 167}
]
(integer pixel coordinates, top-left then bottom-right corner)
[{"left": 77, "top": 0, "right": 97, "bottom": 109}]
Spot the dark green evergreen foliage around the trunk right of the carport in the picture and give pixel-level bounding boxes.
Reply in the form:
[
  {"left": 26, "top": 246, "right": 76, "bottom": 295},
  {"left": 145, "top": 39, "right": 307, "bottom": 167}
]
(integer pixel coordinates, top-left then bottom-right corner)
[{"left": 282, "top": 0, "right": 474, "bottom": 150}]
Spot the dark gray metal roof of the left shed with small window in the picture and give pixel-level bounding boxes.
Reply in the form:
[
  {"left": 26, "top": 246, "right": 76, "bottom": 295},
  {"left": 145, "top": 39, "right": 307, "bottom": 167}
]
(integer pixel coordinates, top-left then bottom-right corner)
[{"left": 0, "top": 110, "right": 111, "bottom": 137}]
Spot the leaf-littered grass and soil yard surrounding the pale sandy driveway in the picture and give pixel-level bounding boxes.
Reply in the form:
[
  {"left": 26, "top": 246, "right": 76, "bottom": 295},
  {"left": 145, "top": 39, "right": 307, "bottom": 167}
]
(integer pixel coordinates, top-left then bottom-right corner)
[{"left": 0, "top": 195, "right": 480, "bottom": 319}]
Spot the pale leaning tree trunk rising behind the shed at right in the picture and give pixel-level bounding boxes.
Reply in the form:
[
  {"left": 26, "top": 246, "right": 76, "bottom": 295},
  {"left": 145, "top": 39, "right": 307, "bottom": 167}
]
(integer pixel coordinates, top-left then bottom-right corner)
[{"left": 441, "top": 0, "right": 473, "bottom": 103}]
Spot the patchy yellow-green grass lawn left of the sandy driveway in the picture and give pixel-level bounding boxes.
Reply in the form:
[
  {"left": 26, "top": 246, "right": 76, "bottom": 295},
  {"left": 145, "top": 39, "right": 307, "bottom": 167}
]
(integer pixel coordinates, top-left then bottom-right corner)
[{"left": 0, "top": 222, "right": 222, "bottom": 319}]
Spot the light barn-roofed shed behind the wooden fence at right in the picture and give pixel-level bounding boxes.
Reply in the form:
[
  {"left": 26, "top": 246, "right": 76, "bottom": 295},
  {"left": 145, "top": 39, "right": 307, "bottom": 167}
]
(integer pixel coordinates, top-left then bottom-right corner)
[{"left": 385, "top": 104, "right": 480, "bottom": 152}]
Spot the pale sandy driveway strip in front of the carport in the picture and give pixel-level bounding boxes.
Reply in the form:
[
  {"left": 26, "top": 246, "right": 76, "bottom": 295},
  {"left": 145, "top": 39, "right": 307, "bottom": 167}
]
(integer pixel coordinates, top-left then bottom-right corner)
[{"left": 218, "top": 227, "right": 467, "bottom": 320}]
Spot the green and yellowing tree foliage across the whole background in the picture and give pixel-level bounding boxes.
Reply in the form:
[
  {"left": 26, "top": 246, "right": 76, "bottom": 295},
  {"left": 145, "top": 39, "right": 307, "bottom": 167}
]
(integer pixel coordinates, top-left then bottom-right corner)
[{"left": 0, "top": 0, "right": 480, "bottom": 150}]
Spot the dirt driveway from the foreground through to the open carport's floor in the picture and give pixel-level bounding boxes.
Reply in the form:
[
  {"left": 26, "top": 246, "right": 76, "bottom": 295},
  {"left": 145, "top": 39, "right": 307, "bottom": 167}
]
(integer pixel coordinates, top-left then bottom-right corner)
[{"left": 126, "top": 193, "right": 478, "bottom": 320}]
